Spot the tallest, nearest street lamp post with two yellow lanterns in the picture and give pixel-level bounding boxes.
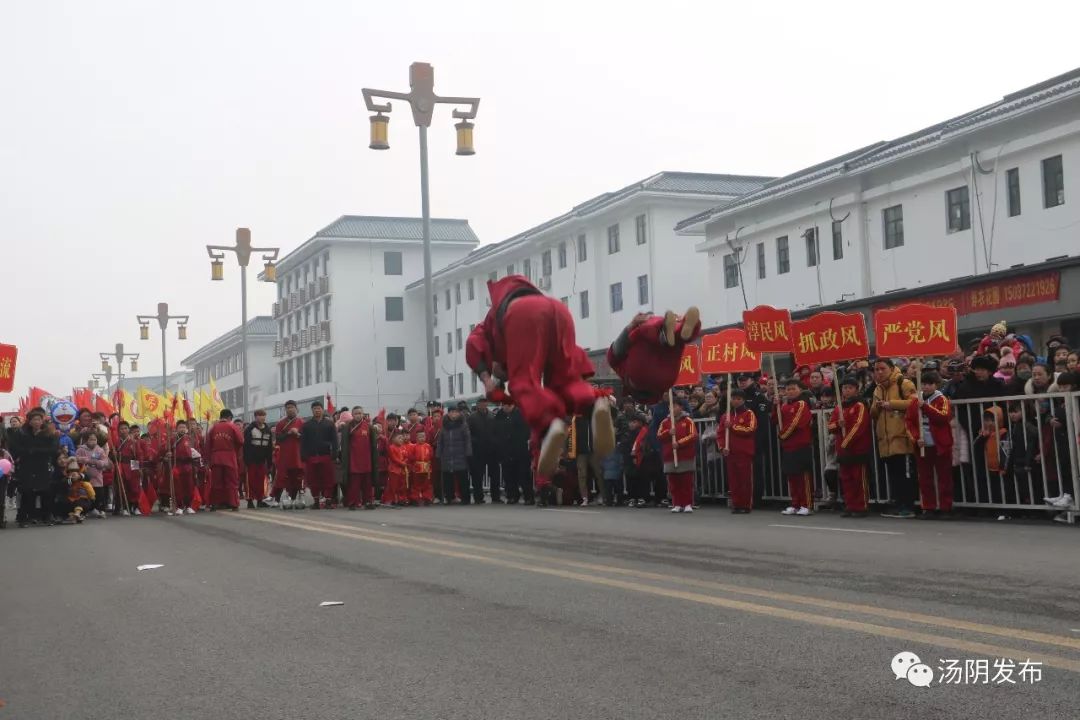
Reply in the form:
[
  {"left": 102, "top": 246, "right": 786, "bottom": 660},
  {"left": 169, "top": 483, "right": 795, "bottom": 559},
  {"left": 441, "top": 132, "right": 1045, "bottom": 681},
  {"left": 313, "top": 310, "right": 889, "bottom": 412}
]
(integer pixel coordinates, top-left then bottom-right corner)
[{"left": 363, "top": 63, "right": 480, "bottom": 399}]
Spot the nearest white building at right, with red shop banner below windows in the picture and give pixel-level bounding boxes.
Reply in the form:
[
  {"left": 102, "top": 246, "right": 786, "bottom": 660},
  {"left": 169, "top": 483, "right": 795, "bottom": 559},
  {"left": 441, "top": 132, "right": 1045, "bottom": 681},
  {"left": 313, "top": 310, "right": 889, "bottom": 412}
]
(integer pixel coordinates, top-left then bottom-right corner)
[{"left": 678, "top": 70, "right": 1080, "bottom": 339}]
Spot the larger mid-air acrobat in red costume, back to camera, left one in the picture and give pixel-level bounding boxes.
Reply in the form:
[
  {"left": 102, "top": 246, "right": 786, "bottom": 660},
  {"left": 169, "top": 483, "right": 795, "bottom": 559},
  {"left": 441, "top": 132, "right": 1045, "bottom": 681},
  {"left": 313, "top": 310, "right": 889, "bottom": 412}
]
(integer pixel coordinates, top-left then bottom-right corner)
[{"left": 465, "top": 275, "right": 615, "bottom": 475}]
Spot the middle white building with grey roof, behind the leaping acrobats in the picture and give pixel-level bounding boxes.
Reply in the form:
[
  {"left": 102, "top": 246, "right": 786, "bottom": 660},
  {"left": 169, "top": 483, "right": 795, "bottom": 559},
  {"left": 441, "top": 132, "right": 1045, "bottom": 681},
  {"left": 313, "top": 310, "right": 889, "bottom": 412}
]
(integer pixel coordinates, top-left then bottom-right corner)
[{"left": 408, "top": 173, "right": 770, "bottom": 402}]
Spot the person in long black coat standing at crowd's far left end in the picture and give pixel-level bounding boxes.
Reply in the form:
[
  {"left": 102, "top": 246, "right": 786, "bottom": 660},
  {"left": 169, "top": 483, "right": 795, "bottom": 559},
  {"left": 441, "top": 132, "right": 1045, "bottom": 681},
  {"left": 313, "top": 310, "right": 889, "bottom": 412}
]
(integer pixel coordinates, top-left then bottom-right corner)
[{"left": 11, "top": 408, "right": 60, "bottom": 528}]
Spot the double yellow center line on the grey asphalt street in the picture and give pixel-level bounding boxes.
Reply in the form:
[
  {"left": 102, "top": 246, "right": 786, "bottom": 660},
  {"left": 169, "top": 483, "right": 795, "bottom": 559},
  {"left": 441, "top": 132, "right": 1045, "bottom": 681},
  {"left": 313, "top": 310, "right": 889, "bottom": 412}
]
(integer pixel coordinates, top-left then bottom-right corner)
[{"left": 226, "top": 513, "right": 1080, "bottom": 674}]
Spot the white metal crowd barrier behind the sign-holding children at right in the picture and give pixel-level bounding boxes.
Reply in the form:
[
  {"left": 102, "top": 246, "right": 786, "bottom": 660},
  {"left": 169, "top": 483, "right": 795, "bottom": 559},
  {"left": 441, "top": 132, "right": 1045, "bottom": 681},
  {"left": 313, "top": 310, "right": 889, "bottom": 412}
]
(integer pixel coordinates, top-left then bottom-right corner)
[{"left": 694, "top": 393, "right": 1080, "bottom": 522}]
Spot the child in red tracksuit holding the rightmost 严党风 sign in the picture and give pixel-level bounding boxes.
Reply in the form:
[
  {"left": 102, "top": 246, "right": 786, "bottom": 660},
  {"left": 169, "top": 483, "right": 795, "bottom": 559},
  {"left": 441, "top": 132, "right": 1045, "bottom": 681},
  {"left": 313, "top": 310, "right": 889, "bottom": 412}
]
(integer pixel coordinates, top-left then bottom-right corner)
[{"left": 904, "top": 370, "right": 953, "bottom": 519}]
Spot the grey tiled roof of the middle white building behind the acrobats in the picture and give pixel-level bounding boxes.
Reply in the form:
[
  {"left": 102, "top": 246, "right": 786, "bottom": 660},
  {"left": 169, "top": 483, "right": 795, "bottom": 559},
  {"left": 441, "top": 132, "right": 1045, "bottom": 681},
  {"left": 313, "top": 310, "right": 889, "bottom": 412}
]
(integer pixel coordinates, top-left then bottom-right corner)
[{"left": 408, "top": 172, "right": 772, "bottom": 288}]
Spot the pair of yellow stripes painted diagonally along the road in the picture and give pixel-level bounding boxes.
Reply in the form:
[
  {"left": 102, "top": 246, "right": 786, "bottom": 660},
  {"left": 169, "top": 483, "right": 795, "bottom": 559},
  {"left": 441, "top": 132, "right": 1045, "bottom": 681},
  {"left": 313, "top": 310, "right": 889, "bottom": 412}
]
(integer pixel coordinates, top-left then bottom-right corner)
[{"left": 228, "top": 514, "right": 1080, "bottom": 674}]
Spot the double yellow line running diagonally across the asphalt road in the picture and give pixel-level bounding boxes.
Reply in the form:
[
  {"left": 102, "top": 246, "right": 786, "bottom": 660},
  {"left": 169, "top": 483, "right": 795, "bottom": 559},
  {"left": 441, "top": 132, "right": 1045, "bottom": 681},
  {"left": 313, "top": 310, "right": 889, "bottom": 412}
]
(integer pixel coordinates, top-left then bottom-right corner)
[{"left": 226, "top": 514, "right": 1080, "bottom": 674}]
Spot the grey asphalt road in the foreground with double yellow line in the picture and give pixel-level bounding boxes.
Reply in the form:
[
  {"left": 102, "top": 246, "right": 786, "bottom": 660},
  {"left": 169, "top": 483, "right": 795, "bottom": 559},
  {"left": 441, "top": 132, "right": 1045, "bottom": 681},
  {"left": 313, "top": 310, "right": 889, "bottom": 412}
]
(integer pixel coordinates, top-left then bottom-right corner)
[{"left": 0, "top": 505, "right": 1080, "bottom": 720}]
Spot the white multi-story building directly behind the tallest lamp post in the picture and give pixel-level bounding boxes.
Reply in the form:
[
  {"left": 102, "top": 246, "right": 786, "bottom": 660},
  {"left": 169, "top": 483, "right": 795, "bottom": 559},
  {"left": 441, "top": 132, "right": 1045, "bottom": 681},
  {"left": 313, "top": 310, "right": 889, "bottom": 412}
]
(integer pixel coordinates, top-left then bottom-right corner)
[{"left": 259, "top": 215, "right": 480, "bottom": 418}]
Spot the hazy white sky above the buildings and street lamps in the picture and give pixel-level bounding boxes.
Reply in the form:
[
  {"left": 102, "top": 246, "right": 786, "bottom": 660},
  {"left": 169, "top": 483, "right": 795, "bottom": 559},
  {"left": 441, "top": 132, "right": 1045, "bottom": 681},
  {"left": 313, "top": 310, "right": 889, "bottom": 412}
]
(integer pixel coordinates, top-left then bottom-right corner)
[{"left": 0, "top": 0, "right": 1080, "bottom": 409}]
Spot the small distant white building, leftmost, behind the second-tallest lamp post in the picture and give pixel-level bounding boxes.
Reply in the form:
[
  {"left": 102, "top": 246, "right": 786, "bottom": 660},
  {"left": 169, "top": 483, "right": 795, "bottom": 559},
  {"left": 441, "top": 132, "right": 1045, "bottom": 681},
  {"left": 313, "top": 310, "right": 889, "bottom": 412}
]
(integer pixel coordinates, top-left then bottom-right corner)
[{"left": 183, "top": 315, "right": 278, "bottom": 420}]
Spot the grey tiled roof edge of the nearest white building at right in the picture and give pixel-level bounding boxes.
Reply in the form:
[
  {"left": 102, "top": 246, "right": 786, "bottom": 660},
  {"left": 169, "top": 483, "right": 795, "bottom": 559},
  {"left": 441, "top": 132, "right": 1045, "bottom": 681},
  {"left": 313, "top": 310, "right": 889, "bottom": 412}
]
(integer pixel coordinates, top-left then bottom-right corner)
[{"left": 675, "top": 68, "right": 1080, "bottom": 231}]
